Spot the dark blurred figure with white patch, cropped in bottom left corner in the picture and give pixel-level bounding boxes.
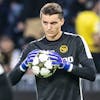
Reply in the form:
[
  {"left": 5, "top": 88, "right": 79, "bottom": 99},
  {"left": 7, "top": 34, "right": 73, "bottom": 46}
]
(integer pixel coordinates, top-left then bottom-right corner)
[{"left": 0, "top": 64, "right": 12, "bottom": 100}]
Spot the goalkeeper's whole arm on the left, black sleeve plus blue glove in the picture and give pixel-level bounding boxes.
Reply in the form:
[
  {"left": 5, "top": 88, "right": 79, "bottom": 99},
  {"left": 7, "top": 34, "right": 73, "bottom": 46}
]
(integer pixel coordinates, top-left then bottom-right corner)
[{"left": 9, "top": 43, "right": 39, "bottom": 85}]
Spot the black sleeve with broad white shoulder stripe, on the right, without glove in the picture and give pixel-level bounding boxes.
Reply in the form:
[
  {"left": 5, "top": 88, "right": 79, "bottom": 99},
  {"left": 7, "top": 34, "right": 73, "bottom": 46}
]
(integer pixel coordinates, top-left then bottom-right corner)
[{"left": 72, "top": 37, "right": 96, "bottom": 81}]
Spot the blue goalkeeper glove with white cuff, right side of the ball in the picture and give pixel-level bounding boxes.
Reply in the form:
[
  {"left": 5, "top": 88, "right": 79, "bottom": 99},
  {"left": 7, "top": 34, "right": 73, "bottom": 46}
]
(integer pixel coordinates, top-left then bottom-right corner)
[{"left": 48, "top": 52, "right": 73, "bottom": 72}]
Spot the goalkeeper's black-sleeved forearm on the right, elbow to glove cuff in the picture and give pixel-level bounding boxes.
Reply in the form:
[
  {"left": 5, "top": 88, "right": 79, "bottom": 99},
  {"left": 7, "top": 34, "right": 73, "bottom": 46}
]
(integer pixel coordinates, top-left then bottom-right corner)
[{"left": 71, "top": 61, "right": 96, "bottom": 81}]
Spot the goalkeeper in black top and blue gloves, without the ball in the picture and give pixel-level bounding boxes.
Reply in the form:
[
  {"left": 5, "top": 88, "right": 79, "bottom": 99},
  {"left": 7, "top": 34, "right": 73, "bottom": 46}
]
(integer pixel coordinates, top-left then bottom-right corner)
[{"left": 9, "top": 3, "right": 96, "bottom": 100}]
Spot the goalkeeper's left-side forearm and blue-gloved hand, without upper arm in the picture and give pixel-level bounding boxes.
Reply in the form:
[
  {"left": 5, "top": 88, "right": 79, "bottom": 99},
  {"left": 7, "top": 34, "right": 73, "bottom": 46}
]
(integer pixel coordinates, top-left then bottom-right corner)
[{"left": 9, "top": 49, "right": 39, "bottom": 85}]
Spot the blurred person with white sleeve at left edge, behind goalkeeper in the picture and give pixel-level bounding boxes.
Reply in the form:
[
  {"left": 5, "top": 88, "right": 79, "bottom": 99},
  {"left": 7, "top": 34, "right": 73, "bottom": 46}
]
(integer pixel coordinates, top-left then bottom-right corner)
[{"left": 0, "top": 35, "right": 20, "bottom": 72}]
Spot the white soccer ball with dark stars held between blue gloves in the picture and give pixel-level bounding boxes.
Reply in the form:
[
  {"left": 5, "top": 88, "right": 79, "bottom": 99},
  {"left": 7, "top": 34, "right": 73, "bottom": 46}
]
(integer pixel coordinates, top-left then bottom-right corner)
[{"left": 31, "top": 50, "right": 57, "bottom": 78}]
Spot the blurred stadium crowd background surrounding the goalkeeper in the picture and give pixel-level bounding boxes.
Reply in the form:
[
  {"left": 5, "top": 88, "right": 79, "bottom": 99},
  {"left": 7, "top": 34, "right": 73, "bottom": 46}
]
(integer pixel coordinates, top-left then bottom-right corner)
[{"left": 0, "top": 0, "right": 100, "bottom": 100}]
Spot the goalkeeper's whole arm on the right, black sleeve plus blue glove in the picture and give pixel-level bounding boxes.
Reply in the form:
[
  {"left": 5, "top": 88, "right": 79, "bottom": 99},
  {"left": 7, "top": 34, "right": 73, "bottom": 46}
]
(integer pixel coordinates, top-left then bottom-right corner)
[{"left": 49, "top": 37, "right": 96, "bottom": 81}]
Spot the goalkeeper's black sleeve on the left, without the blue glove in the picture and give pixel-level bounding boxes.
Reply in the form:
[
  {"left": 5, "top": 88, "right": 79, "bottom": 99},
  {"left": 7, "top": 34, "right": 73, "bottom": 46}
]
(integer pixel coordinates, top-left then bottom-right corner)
[{"left": 8, "top": 44, "right": 31, "bottom": 85}]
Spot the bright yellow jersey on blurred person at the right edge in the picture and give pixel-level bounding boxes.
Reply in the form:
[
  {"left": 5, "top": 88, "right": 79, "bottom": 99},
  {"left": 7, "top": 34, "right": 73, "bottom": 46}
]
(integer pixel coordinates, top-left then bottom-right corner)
[{"left": 75, "top": 11, "right": 100, "bottom": 53}]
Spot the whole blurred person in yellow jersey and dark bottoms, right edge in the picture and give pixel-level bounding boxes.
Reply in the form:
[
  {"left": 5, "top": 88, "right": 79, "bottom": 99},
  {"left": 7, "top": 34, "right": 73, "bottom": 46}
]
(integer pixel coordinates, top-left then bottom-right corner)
[{"left": 76, "top": 0, "right": 100, "bottom": 73}]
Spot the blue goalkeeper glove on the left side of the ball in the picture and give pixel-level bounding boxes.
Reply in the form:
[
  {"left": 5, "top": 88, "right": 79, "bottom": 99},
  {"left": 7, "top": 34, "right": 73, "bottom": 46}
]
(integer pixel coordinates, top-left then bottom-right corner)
[{"left": 20, "top": 49, "right": 40, "bottom": 71}]
